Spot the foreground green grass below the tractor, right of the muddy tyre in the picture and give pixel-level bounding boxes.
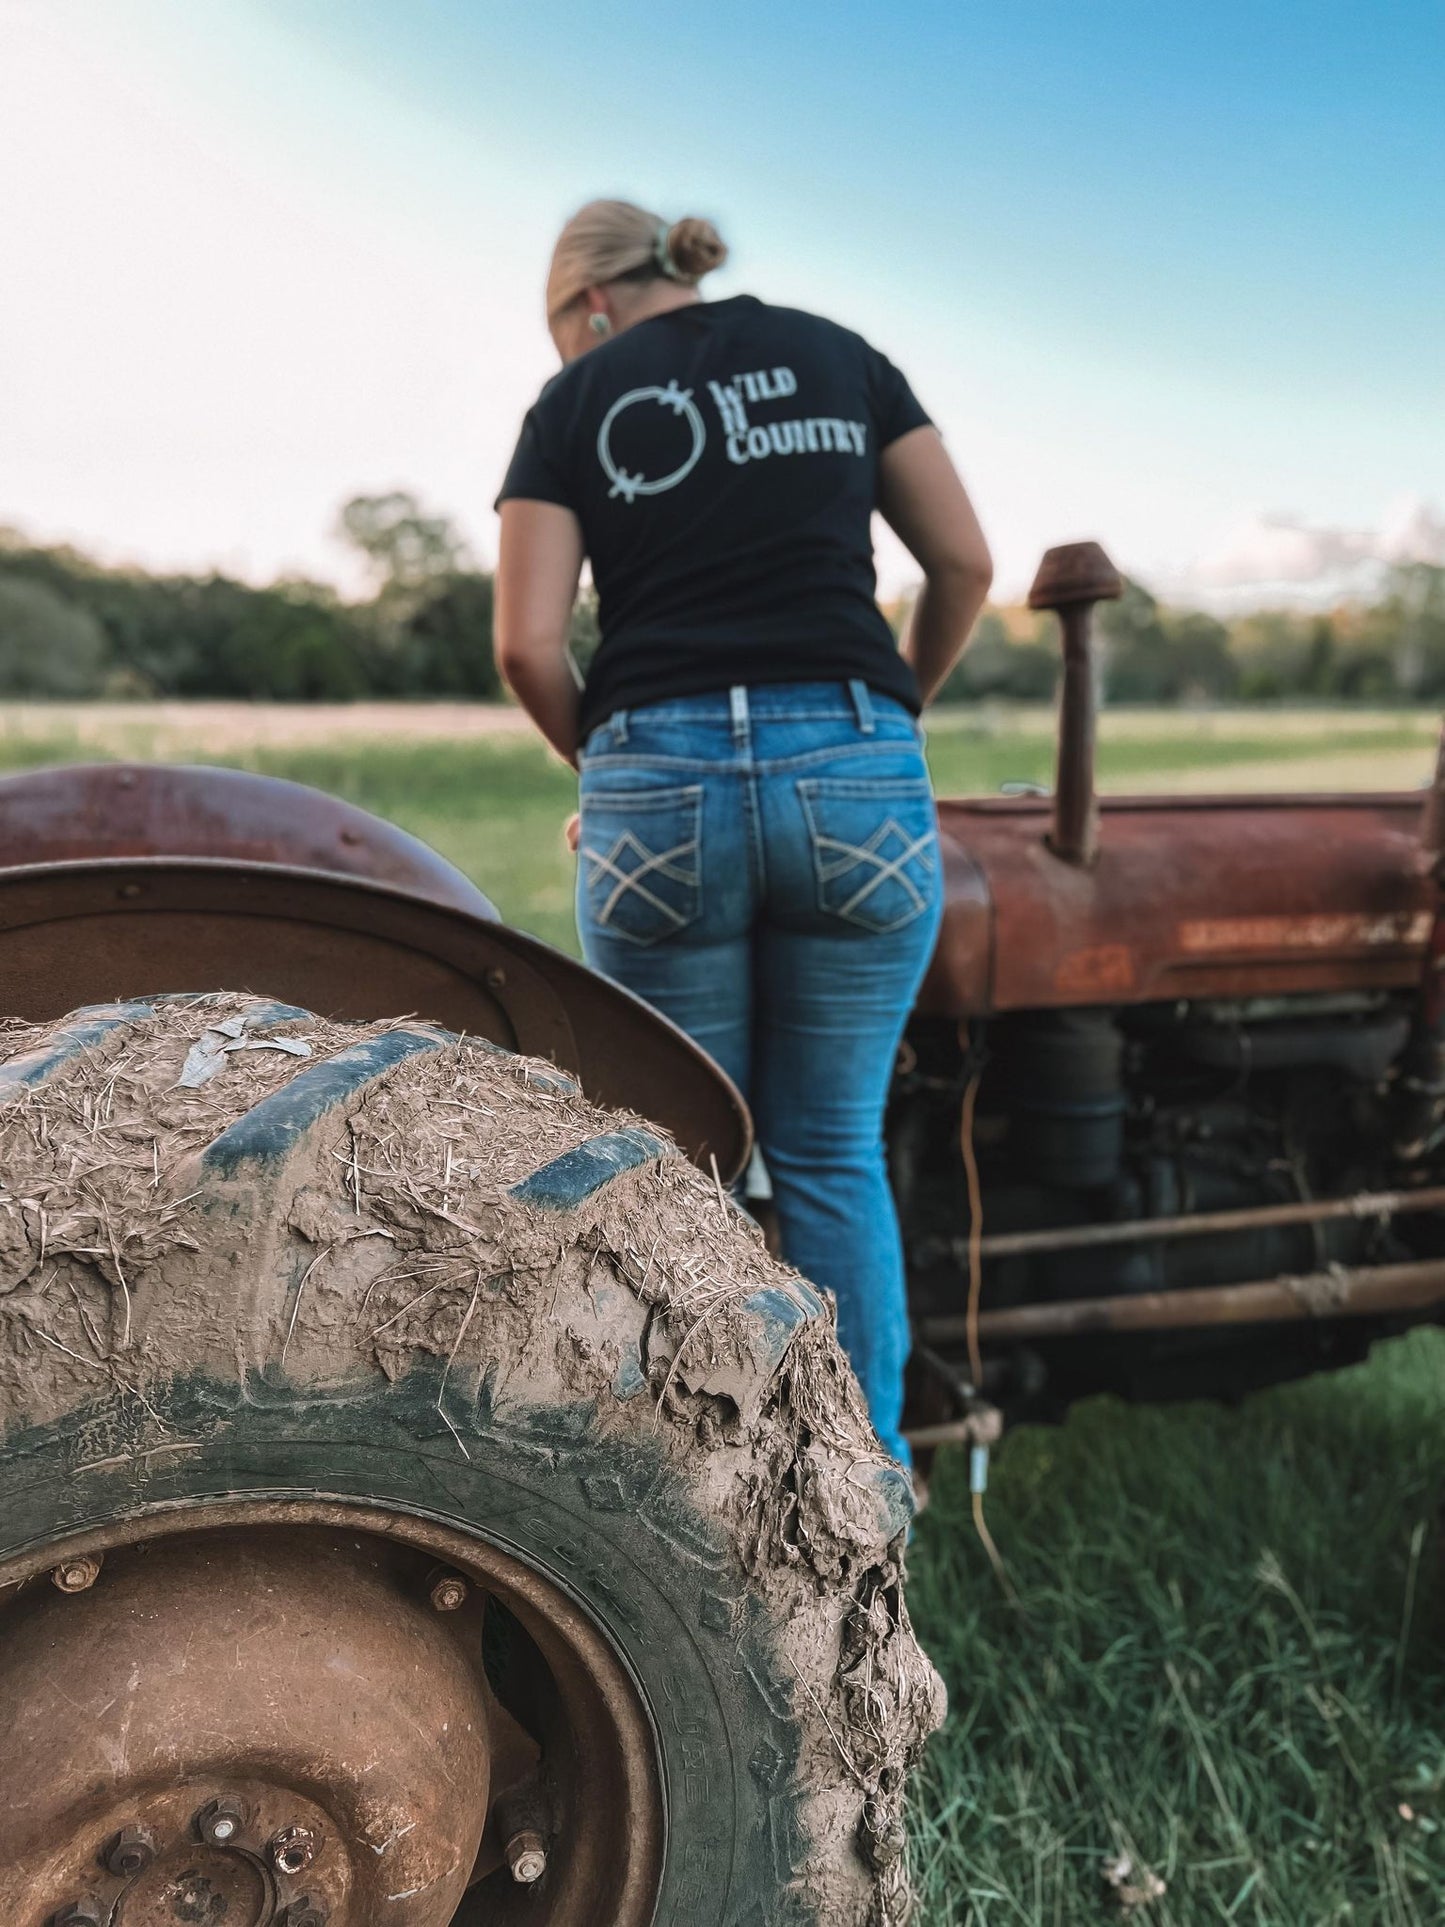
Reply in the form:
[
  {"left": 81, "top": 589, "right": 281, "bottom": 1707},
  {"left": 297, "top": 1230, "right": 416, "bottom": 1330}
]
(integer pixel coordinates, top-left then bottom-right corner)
[{"left": 909, "top": 1332, "right": 1445, "bottom": 1927}]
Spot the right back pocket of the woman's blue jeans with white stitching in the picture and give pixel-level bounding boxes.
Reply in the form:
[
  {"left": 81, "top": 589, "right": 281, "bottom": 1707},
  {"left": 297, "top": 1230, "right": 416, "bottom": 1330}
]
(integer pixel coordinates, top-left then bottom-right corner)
[{"left": 798, "top": 777, "right": 938, "bottom": 933}]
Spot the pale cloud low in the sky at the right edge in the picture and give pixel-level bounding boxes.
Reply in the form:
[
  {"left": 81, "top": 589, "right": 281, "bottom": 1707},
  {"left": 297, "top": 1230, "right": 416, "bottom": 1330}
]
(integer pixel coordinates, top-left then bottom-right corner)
[{"left": 1189, "top": 495, "right": 1445, "bottom": 594}]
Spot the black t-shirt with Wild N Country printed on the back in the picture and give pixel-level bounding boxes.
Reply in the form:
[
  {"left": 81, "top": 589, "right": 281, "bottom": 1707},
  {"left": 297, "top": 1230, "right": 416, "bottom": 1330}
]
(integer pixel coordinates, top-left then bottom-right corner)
[{"left": 499, "top": 295, "right": 929, "bottom": 734}]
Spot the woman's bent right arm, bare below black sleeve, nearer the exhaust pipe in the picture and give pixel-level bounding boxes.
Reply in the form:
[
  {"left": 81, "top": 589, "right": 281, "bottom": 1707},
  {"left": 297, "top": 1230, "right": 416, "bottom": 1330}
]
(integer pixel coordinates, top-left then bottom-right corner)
[{"left": 879, "top": 428, "right": 994, "bottom": 703}]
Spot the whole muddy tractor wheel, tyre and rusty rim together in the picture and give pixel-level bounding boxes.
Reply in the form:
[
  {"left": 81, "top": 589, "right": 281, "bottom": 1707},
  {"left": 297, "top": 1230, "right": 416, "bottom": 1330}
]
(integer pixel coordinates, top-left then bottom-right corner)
[{"left": 0, "top": 994, "right": 942, "bottom": 1927}]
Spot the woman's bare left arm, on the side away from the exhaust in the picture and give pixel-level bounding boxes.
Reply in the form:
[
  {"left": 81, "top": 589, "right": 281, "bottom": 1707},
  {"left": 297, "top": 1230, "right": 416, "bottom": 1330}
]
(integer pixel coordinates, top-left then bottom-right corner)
[{"left": 493, "top": 501, "right": 584, "bottom": 763}]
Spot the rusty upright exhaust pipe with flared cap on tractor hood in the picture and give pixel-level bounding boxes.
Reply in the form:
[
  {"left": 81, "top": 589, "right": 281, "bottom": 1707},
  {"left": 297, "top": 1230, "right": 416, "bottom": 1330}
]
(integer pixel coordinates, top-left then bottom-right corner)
[{"left": 1029, "top": 541, "right": 1123, "bottom": 869}]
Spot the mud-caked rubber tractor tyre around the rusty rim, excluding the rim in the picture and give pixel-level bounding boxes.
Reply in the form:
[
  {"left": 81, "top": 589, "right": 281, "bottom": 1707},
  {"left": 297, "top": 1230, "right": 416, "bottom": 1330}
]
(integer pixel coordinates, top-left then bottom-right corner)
[{"left": 0, "top": 996, "right": 942, "bottom": 1927}]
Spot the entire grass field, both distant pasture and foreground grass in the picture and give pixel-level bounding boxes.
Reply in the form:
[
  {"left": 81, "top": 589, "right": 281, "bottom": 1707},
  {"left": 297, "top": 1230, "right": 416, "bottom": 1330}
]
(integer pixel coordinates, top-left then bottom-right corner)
[{"left": 0, "top": 705, "right": 1445, "bottom": 1927}]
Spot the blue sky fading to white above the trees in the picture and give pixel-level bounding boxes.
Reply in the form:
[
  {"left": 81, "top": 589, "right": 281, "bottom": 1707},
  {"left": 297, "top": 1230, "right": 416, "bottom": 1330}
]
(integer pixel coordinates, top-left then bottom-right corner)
[{"left": 0, "top": 0, "right": 1445, "bottom": 601}]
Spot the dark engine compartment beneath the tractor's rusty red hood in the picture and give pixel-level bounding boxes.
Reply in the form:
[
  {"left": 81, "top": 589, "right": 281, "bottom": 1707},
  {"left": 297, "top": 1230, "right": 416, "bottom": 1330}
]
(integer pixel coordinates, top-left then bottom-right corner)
[{"left": 888, "top": 992, "right": 1445, "bottom": 1409}]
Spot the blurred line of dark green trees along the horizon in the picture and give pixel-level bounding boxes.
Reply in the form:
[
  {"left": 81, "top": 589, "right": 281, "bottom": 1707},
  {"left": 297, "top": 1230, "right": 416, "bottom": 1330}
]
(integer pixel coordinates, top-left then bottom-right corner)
[{"left": 0, "top": 493, "right": 1445, "bottom": 703}]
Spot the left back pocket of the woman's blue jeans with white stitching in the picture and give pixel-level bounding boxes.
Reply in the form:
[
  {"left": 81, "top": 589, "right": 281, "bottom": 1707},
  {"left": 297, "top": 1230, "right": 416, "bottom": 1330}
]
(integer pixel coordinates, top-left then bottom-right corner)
[{"left": 578, "top": 782, "right": 703, "bottom": 944}]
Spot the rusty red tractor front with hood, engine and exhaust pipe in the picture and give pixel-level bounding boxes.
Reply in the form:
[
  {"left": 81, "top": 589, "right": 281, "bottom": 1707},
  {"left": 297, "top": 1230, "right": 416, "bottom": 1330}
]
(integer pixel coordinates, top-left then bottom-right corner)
[{"left": 888, "top": 543, "right": 1445, "bottom": 1438}]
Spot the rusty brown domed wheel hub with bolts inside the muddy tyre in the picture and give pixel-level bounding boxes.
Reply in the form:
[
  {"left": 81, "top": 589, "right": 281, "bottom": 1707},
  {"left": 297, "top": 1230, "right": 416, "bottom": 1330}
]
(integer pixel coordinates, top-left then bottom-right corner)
[{"left": 0, "top": 1528, "right": 491, "bottom": 1927}]
